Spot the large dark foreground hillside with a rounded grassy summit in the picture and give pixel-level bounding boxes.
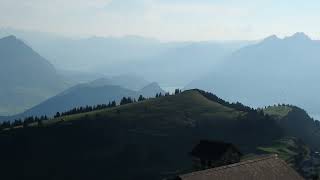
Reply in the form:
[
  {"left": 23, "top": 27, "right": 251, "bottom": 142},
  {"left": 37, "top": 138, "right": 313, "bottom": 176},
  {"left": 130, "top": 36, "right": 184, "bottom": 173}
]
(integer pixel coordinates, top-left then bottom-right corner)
[{"left": 0, "top": 90, "right": 283, "bottom": 180}]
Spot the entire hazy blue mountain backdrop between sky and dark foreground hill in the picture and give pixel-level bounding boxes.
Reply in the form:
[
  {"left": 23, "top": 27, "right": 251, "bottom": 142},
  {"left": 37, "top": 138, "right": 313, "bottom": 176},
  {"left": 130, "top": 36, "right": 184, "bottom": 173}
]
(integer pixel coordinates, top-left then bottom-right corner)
[{"left": 0, "top": 31, "right": 320, "bottom": 119}]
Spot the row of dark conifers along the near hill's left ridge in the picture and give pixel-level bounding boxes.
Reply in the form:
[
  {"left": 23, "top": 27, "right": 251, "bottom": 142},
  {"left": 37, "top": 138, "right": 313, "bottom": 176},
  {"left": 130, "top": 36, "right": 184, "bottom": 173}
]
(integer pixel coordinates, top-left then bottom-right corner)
[{"left": 0, "top": 89, "right": 175, "bottom": 131}]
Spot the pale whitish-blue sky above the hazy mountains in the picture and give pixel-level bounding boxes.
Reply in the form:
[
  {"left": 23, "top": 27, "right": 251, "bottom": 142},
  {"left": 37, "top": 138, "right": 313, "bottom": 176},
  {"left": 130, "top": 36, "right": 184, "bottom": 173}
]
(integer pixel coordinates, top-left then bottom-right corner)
[{"left": 0, "top": 0, "right": 320, "bottom": 41}]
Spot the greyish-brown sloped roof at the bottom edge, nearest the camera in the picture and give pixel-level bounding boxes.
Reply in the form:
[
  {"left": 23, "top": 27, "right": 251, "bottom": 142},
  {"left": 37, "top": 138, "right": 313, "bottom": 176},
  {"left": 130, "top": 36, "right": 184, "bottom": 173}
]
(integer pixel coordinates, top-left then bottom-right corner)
[{"left": 179, "top": 155, "right": 303, "bottom": 180}]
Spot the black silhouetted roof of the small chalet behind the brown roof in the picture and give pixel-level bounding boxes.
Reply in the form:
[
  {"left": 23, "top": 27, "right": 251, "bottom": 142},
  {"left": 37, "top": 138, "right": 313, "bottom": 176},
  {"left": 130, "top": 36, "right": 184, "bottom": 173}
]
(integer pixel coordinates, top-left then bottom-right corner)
[{"left": 190, "top": 140, "right": 241, "bottom": 160}]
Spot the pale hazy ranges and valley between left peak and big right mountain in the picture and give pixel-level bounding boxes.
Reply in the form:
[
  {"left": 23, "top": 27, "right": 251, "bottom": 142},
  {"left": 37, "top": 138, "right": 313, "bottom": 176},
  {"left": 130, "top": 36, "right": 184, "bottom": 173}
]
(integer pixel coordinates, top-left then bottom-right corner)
[{"left": 0, "top": 29, "right": 253, "bottom": 86}]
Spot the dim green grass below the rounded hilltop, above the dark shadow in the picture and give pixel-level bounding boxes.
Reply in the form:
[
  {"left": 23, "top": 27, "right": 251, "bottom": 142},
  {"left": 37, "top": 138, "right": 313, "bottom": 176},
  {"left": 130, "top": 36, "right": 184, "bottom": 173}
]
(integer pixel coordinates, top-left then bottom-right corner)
[{"left": 59, "top": 91, "right": 243, "bottom": 125}]
